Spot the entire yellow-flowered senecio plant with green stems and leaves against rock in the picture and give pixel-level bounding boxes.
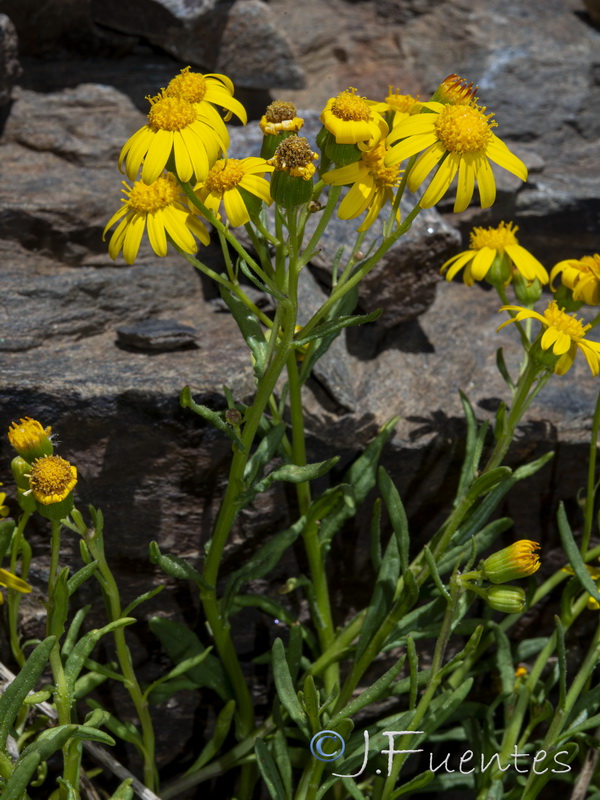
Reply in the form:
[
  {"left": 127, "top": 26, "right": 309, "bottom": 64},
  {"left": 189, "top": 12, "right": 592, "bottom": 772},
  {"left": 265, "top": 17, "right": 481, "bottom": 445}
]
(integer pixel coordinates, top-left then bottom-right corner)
[{"left": 5, "top": 68, "right": 600, "bottom": 800}]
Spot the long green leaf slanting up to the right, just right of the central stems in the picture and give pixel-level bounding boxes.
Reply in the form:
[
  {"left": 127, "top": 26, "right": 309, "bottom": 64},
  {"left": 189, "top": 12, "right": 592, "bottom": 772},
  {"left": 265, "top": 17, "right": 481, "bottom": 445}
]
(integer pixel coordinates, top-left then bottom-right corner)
[{"left": 319, "top": 417, "right": 399, "bottom": 550}]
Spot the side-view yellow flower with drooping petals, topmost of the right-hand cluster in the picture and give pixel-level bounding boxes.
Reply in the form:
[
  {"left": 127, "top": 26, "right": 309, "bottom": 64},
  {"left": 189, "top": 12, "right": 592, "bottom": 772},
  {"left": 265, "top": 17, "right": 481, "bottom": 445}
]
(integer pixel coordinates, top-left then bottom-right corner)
[{"left": 440, "top": 222, "right": 548, "bottom": 286}]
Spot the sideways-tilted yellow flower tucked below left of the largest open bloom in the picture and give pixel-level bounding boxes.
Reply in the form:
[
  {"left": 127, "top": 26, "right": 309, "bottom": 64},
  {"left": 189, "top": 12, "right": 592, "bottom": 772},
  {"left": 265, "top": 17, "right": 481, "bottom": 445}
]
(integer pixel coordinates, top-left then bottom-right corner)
[{"left": 322, "top": 143, "right": 400, "bottom": 231}]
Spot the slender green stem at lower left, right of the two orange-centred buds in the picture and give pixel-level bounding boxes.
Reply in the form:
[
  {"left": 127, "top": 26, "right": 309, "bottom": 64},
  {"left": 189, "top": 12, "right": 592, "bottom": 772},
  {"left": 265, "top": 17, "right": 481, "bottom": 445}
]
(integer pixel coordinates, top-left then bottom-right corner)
[{"left": 85, "top": 531, "right": 158, "bottom": 791}]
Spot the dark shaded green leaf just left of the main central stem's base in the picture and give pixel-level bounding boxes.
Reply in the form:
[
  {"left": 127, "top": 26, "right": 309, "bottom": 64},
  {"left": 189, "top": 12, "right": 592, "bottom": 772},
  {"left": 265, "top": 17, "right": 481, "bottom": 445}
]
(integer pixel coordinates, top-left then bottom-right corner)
[{"left": 149, "top": 617, "right": 232, "bottom": 701}]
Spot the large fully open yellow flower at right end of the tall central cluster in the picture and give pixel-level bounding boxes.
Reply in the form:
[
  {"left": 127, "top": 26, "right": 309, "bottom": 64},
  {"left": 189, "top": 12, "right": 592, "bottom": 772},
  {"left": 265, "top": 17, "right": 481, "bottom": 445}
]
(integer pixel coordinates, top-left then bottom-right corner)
[{"left": 386, "top": 91, "right": 527, "bottom": 212}]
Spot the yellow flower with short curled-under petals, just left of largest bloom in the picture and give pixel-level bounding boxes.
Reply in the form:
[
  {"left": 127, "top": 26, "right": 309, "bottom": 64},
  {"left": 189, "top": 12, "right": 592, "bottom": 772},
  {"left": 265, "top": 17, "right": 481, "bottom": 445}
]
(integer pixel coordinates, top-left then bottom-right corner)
[{"left": 320, "top": 89, "right": 388, "bottom": 149}]
